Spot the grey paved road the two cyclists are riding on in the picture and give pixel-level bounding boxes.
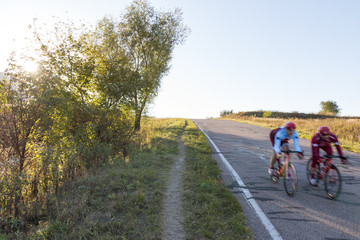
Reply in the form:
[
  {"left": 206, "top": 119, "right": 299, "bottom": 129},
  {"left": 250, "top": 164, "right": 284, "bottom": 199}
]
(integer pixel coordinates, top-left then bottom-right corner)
[{"left": 194, "top": 119, "right": 360, "bottom": 240}]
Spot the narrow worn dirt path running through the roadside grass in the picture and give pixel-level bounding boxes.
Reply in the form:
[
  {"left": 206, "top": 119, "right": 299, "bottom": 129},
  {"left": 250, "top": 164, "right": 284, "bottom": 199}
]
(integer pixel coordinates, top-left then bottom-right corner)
[{"left": 162, "top": 131, "right": 186, "bottom": 240}]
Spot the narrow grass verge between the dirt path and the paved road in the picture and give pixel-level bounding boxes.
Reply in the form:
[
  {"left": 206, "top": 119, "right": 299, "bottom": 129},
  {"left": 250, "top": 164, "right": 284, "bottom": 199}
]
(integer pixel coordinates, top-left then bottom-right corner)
[{"left": 183, "top": 121, "right": 253, "bottom": 239}]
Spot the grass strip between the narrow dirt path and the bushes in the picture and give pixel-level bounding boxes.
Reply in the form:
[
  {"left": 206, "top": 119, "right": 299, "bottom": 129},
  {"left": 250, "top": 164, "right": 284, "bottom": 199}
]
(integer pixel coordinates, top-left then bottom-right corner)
[{"left": 28, "top": 118, "right": 185, "bottom": 239}]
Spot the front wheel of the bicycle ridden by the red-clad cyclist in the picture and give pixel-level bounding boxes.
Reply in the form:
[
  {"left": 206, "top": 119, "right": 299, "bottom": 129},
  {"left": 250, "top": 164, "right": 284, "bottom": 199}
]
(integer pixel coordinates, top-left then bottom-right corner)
[{"left": 324, "top": 165, "right": 342, "bottom": 199}]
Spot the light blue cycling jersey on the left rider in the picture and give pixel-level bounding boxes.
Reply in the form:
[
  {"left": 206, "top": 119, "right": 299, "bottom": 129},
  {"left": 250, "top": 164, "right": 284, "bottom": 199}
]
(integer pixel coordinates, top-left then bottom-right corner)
[{"left": 270, "top": 127, "right": 301, "bottom": 154}]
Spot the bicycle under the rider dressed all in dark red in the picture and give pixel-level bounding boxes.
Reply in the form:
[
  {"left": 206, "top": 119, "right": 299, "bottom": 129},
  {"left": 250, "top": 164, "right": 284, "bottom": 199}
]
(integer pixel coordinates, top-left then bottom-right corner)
[{"left": 306, "top": 155, "right": 347, "bottom": 200}]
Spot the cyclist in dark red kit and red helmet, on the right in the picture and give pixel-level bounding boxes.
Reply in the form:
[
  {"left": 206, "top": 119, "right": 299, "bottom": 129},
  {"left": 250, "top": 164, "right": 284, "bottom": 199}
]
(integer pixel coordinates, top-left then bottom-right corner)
[{"left": 310, "top": 126, "right": 347, "bottom": 186}]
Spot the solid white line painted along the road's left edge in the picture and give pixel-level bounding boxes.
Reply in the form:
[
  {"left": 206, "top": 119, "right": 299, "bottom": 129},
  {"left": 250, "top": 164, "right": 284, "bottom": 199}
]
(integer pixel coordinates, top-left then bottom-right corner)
[{"left": 194, "top": 121, "right": 282, "bottom": 240}]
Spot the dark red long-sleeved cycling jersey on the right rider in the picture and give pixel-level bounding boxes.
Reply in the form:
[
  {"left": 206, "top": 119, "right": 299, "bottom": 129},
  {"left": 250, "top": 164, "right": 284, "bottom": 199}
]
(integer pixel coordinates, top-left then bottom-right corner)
[{"left": 311, "top": 133, "right": 344, "bottom": 167}]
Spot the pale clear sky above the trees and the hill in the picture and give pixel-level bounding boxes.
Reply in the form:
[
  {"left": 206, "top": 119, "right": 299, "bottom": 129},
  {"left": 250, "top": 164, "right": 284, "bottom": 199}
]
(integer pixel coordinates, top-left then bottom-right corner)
[{"left": 0, "top": 0, "right": 360, "bottom": 119}]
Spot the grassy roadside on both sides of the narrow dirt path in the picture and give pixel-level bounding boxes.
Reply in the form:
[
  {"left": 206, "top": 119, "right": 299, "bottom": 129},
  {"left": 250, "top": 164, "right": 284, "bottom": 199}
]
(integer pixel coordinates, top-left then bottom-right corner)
[{"left": 5, "top": 119, "right": 252, "bottom": 240}]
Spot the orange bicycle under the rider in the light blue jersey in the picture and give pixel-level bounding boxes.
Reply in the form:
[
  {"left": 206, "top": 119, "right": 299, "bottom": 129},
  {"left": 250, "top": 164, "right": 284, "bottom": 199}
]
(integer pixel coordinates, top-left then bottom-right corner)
[{"left": 271, "top": 150, "right": 303, "bottom": 197}]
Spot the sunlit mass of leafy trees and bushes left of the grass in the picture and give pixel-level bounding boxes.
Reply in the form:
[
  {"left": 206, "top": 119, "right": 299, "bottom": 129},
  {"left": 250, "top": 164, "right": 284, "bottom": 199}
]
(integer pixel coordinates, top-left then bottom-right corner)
[{"left": 0, "top": 0, "right": 189, "bottom": 230}]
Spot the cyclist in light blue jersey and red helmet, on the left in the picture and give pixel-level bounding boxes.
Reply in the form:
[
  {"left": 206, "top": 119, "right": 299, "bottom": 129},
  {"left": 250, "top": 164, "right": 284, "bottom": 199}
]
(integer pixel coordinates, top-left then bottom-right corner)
[{"left": 268, "top": 122, "right": 304, "bottom": 175}]
